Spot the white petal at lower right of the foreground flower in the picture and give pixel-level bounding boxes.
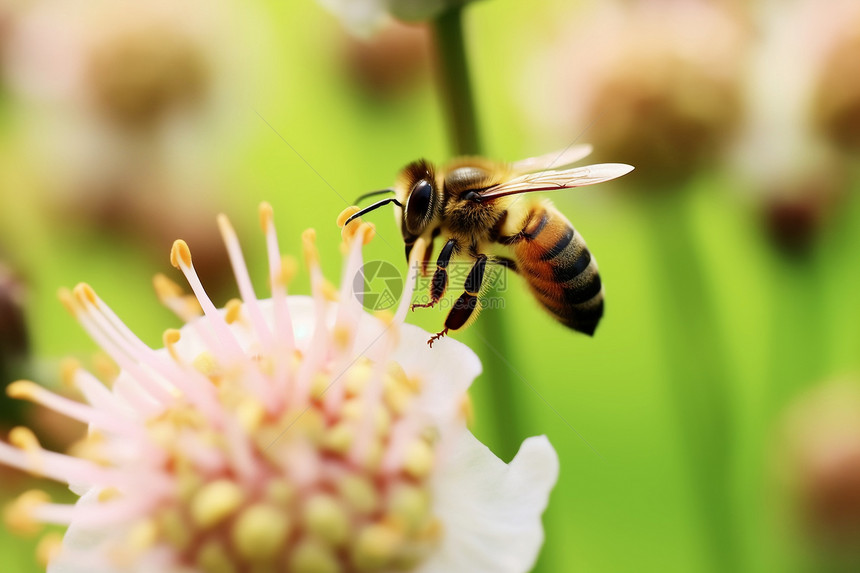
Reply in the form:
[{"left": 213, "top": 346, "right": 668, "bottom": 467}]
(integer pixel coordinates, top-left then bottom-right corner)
[{"left": 418, "top": 430, "right": 558, "bottom": 573}]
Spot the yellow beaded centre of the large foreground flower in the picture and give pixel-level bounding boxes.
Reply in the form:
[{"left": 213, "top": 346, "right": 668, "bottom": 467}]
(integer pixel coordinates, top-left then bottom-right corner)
[{"left": 79, "top": 350, "right": 441, "bottom": 573}]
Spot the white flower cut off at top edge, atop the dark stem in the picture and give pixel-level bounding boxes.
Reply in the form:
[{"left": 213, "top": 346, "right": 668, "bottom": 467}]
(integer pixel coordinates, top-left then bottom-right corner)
[{"left": 319, "top": 0, "right": 469, "bottom": 37}]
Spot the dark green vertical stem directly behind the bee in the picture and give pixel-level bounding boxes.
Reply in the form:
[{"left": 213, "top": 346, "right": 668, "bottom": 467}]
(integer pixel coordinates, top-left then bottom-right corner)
[{"left": 434, "top": 6, "right": 525, "bottom": 459}]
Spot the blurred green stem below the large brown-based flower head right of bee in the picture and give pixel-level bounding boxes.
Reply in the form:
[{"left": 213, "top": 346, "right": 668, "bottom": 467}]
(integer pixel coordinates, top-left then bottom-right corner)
[{"left": 645, "top": 191, "right": 742, "bottom": 572}]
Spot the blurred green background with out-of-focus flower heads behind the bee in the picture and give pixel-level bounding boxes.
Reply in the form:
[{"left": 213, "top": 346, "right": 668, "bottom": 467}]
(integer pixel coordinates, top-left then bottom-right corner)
[{"left": 0, "top": 0, "right": 860, "bottom": 572}]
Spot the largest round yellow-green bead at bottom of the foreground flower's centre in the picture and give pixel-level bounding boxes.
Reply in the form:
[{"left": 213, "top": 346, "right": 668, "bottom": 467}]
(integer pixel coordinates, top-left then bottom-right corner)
[{"left": 231, "top": 504, "right": 291, "bottom": 561}]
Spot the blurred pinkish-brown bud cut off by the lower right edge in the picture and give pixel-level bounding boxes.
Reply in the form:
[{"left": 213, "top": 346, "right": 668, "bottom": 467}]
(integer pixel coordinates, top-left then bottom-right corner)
[{"left": 784, "top": 379, "right": 860, "bottom": 556}]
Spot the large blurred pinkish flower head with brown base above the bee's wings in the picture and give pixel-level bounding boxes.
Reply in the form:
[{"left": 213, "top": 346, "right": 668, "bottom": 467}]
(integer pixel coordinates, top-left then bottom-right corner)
[{"left": 523, "top": 1, "right": 744, "bottom": 187}]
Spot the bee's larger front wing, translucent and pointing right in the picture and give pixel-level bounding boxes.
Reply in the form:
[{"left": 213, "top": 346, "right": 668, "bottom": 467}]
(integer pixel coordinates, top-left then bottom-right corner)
[{"left": 480, "top": 163, "right": 633, "bottom": 199}]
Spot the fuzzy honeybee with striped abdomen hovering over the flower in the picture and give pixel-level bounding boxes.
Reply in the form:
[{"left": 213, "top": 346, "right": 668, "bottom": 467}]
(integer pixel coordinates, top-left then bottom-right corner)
[{"left": 344, "top": 145, "right": 633, "bottom": 347}]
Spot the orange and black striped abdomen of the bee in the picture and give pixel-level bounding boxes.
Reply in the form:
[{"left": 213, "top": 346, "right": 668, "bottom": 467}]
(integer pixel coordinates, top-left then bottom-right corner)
[{"left": 502, "top": 203, "right": 603, "bottom": 336}]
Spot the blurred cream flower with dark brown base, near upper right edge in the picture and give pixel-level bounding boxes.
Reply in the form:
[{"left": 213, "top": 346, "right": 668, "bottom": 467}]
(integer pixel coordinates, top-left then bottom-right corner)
[{"left": 736, "top": 0, "right": 860, "bottom": 255}]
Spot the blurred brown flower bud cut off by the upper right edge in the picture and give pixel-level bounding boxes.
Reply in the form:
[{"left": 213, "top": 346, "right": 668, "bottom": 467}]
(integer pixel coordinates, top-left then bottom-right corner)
[{"left": 812, "top": 6, "right": 860, "bottom": 152}]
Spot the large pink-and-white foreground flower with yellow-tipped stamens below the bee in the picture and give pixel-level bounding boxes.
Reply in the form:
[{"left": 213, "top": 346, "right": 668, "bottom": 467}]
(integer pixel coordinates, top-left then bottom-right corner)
[{"left": 0, "top": 204, "right": 558, "bottom": 573}]
